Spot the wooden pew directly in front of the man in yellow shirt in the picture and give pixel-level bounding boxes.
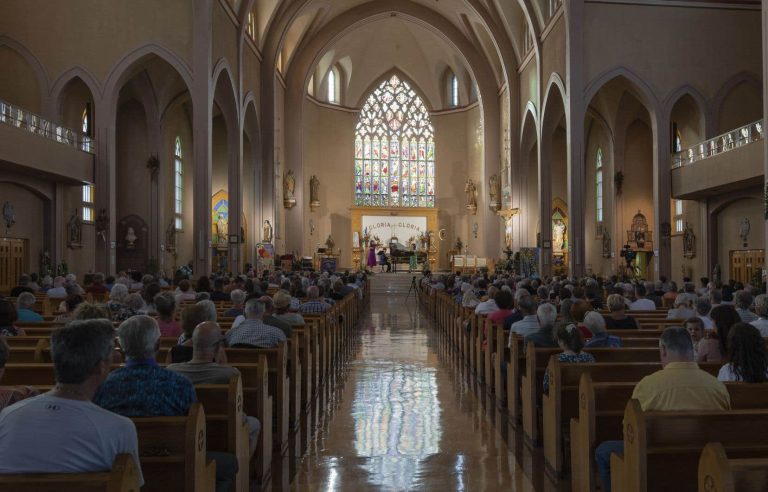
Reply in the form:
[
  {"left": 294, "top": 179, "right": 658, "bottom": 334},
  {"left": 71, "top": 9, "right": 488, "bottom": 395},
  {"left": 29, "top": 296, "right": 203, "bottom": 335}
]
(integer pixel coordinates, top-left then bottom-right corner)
[{"left": 570, "top": 378, "right": 768, "bottom": 492}]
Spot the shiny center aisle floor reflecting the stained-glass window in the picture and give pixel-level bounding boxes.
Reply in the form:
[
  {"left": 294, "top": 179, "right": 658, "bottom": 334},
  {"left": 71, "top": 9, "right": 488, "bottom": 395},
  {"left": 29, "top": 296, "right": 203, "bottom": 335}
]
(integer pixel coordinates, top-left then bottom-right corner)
[{"left": 291, "top": 274, "right": 534, "bottom": 491}]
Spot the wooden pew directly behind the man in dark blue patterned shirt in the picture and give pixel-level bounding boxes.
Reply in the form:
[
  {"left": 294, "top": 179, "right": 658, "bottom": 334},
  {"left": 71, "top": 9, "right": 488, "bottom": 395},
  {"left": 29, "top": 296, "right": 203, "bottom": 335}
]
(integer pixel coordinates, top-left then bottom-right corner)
[{"left": 131, "top": 403, "right": 216, "bottom": 492}]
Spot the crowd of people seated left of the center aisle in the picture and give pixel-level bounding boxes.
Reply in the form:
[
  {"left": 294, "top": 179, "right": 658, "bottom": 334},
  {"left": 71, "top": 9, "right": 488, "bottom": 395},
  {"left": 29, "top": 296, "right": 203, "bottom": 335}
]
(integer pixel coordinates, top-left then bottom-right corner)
[{"left": 0, "top": 270, "right": 365, "bottom": 491}]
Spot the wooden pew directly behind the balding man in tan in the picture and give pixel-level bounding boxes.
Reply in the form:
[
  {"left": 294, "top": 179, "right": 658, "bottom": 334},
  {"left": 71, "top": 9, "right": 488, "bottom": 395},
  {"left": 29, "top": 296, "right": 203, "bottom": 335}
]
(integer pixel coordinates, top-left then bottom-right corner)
[{"left": 195, "top": 375, "right": 251, "bottom": 492}]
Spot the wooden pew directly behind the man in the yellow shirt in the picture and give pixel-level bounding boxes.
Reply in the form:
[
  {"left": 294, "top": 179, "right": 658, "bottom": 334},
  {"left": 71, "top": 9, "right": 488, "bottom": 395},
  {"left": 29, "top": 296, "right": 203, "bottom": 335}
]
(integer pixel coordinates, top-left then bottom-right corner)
[{"left": 611, "top": 400, "right": 768, "bottom": 492}]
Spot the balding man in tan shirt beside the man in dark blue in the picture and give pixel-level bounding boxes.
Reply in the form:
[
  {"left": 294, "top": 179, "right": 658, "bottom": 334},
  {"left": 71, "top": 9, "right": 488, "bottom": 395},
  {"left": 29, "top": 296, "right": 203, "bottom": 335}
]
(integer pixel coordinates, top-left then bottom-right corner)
[{"left": 168, "top": 321, "right": 261, "bottom": 454}]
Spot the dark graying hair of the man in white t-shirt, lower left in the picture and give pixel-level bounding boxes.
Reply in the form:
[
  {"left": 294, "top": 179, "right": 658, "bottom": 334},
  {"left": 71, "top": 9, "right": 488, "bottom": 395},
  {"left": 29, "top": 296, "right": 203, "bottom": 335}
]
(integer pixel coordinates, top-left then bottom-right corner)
[{"left": 51, "top": 319, "right": 115, "bottom": 384}]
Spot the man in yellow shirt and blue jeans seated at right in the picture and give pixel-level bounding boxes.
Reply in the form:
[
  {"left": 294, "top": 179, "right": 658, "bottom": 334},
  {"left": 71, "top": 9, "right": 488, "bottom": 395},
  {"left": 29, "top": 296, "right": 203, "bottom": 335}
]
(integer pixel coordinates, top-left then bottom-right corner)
[{"left": 595, "top": 326, "right": 731, "bottom": 492}]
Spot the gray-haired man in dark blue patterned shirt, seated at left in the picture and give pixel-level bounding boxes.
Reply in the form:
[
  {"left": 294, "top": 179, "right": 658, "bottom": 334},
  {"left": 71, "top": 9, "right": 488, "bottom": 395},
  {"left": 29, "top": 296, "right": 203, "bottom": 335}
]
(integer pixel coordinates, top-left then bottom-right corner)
[{"left": 93, "top": 315, "right": 238, "bottom": 492}]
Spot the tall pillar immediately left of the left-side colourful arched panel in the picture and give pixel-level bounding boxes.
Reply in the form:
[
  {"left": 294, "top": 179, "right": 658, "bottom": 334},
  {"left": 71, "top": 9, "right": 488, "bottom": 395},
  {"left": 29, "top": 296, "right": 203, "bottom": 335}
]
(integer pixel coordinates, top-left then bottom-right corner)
[{"left": 192, "top": 0, "right": 213, "bottom": 277}]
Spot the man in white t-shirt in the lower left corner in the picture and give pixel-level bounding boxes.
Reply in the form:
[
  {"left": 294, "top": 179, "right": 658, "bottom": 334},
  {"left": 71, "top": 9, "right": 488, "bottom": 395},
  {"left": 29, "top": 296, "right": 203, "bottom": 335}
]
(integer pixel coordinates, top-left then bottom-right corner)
[{"left": 0, "top": 320, "right": 144, "bottom": 485}]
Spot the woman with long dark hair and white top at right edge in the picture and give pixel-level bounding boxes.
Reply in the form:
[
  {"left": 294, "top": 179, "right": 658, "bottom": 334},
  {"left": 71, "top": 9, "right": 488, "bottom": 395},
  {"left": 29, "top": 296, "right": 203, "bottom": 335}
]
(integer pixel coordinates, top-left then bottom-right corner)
[{"left": 717, "top": 322, "right": 768, "bottom": 383}]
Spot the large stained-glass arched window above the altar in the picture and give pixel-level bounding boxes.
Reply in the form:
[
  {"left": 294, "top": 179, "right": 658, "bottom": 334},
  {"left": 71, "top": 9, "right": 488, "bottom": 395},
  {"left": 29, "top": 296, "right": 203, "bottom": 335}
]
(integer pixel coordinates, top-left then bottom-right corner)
[{"left": 355, "top": 75, "right": 435, "bottom": 207}]
